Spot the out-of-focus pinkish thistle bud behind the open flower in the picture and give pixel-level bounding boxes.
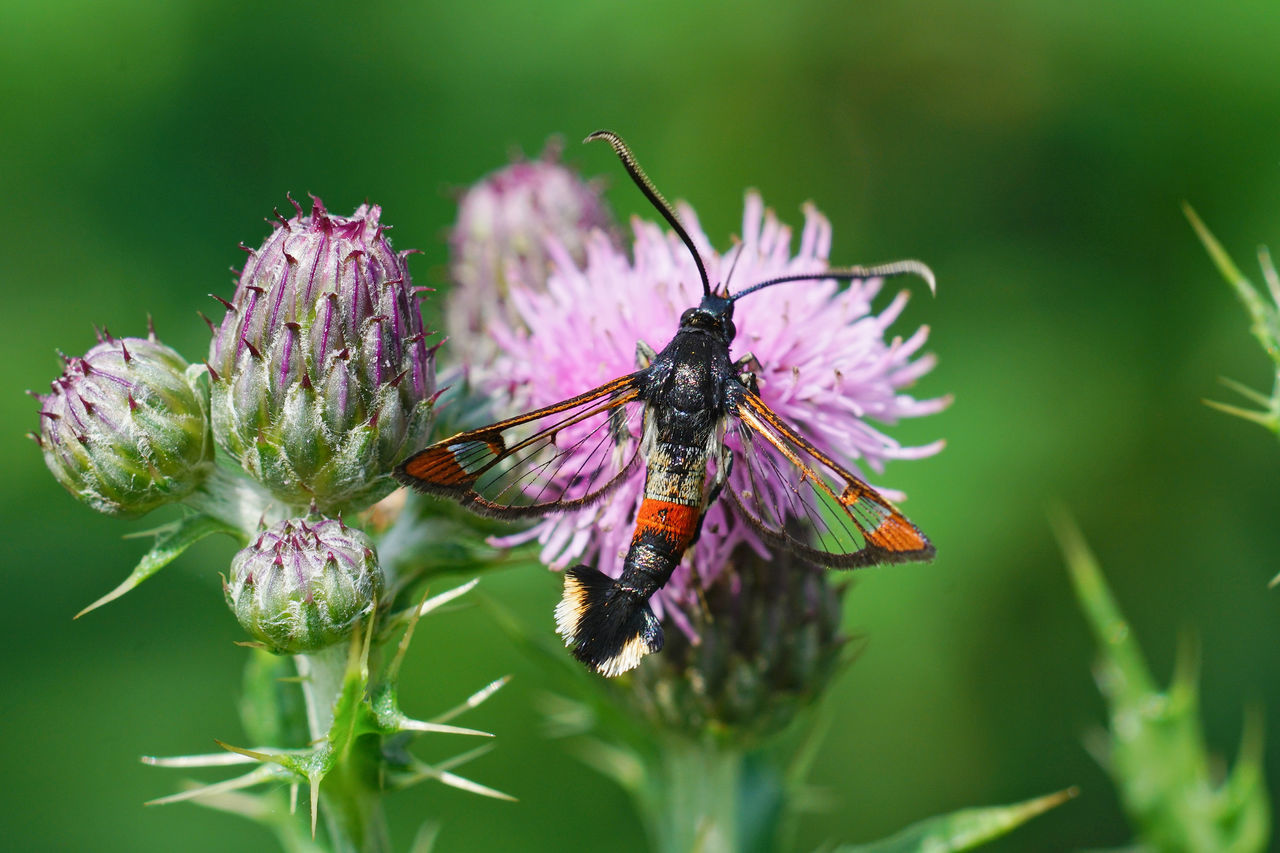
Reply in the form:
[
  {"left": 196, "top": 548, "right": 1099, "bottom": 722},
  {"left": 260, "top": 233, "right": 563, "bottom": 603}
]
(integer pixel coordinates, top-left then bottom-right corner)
[{"left": 445, "top": 143, "right": 614, "bottom": 365}]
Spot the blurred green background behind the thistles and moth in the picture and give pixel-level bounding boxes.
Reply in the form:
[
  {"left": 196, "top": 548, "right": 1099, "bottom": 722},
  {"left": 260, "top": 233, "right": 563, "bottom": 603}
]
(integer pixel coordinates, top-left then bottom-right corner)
[{"left": 0, "top": 0, "right": 1280, "bottom": 852}]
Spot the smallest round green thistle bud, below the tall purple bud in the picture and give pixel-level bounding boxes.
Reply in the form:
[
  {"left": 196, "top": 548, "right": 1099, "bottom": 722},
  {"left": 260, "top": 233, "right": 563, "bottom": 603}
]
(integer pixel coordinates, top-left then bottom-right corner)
[{"left": 223, "top": 516, "right": 383, "bottom": 654}]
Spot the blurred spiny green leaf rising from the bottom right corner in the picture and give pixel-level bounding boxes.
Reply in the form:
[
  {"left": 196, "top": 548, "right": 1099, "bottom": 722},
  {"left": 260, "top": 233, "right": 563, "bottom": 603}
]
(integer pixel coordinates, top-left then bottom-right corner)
[{"left": 1052, "top": 511, "right": 1271, "bottom": 853}]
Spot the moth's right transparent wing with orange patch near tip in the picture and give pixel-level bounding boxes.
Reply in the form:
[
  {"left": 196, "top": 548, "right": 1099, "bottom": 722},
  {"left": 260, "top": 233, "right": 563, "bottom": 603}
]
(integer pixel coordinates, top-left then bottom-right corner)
[{"left": 726, "top": 386, "right": 934, "bottom": 569}]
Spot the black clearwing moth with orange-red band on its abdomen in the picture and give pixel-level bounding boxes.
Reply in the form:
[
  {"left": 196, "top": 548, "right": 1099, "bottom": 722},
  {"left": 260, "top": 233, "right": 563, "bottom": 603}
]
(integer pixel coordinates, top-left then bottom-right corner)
[{"left": 396, "top": 131, "right": 934, "bottom": 676}]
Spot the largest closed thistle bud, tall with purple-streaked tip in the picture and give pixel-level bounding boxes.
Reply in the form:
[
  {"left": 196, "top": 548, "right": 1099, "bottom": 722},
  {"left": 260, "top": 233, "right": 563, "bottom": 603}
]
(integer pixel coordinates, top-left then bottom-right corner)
[{"left": 209, "top": 199, "right": 435, "bottom": 511}]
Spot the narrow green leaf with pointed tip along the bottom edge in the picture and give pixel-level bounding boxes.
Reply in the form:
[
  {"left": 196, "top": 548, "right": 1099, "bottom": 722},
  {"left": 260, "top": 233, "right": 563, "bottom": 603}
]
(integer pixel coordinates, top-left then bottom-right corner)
[{"left": 836, "top": 788, "right": 1076, "bottom": 853}]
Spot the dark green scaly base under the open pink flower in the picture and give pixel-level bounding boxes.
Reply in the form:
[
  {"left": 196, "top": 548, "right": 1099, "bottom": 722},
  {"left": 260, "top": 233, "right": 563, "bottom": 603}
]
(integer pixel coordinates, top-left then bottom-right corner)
[{"left": 628, "top": 546, "right": 847, "bottom": 742}]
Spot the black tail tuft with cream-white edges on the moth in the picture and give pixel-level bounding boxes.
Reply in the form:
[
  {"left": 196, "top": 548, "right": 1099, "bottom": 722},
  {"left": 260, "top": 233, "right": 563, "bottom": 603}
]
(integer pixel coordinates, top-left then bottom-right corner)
[{"left": 556, "top": 566, "right": 662, "bottom": 676}]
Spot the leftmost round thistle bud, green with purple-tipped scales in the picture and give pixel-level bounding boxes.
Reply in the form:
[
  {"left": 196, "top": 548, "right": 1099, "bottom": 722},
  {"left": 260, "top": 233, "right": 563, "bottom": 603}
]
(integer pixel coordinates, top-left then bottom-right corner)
[{"left": 33, "top": 333, "right": 214, "bottom": 516}]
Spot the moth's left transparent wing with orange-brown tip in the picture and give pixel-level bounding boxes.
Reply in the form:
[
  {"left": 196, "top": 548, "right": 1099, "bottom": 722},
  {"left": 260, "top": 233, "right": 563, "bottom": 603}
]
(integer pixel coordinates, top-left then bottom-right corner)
[{"left": 396, "top": 371, "right": 644, "bottom": 519}]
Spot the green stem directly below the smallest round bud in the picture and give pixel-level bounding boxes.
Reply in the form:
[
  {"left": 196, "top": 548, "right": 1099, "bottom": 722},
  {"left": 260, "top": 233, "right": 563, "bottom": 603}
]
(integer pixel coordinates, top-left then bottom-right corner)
[{"left": 294, "top": 643, "right": 390, "bottom": 853}]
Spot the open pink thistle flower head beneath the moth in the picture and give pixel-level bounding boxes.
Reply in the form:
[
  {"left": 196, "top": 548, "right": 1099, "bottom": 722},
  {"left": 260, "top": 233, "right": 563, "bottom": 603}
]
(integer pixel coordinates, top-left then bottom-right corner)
[{"left": 472, "top": 192, "right": 948, "bottom": 633}]
